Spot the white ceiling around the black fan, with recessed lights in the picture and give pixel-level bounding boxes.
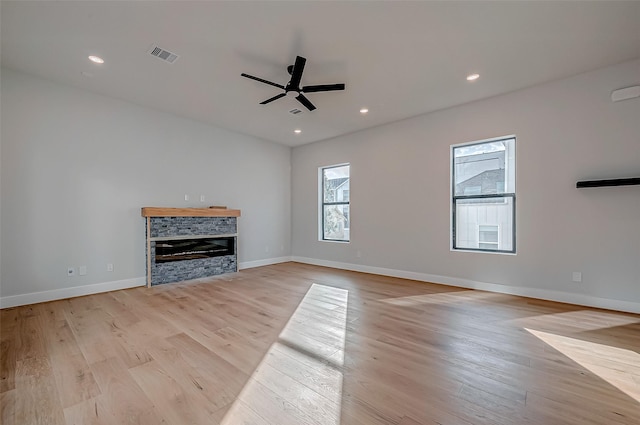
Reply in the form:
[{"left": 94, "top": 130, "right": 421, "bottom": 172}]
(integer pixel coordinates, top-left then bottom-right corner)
[{"left": 0, "top": 0, "right": 640, "bottom": 146}]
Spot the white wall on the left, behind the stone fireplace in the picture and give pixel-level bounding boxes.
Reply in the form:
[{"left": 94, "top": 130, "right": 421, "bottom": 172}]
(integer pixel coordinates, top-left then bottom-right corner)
[{"left": 1, "top": 69, "right": 291, "bottom": 306}]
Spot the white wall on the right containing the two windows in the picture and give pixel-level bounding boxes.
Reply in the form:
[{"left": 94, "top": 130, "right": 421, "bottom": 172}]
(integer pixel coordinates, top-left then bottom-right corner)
[{"left": 292, "top": 60, "right": 640, "bottom": 312}]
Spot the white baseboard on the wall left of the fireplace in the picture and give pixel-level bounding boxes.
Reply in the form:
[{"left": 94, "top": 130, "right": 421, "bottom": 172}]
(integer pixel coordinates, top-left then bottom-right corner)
[{"left": 0, "top": 277, "right": 147, "bottom": 308}]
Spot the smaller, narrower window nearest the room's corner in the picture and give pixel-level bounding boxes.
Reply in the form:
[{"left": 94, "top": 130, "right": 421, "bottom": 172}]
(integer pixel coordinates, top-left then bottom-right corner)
[{"left": 320, "top": 164, "right": 350, "bottom": 242}]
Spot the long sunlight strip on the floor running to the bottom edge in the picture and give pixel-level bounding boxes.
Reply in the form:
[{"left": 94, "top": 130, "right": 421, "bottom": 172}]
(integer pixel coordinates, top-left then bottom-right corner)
[{"left": 221, "top": 284, "right": 349, "bottom": 425}]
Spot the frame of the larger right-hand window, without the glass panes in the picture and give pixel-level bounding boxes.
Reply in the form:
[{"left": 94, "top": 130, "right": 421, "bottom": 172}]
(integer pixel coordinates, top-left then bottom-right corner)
[{"left": 449, "top": 135, "right": 517, "bottom": 255}]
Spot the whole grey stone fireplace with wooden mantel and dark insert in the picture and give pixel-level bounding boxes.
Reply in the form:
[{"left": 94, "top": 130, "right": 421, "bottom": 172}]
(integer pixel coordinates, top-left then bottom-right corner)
[{"left": 142, "top": 207, "right": 240, "bottom": 287}]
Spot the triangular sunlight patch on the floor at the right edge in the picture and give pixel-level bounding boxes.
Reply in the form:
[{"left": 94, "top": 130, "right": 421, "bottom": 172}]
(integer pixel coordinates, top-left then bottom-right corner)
[{"left": 525, "top": 328, "right": 640, "bottom": 402}]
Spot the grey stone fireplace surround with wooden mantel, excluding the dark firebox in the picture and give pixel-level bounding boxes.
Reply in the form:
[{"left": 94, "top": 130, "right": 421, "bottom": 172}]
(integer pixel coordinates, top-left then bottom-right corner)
[{"left": 142, "top": 207, "right": 240, "bottom": 287}]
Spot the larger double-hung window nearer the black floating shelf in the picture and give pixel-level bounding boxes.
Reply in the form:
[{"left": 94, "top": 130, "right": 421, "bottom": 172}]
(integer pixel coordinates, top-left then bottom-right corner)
[{"left": 451, "top": 136, "right": 516, "bottom": 253}]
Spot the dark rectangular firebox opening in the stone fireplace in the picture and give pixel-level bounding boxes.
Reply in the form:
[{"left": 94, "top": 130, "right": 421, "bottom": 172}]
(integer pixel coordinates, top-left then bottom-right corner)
[{"left": 155, "top": 237, "right": 235, "bottom": 263}]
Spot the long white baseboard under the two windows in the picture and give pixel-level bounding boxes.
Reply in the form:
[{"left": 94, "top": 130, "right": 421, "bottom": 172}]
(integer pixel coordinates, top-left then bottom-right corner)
[{"left": 291, "top": 256, "right": 640, "bottom": 314}]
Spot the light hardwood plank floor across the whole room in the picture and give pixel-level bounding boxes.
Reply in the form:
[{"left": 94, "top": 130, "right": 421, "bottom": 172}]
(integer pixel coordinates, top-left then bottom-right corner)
[{"left": 0, "top": 263, "right": 640, "bottom": 425}]
